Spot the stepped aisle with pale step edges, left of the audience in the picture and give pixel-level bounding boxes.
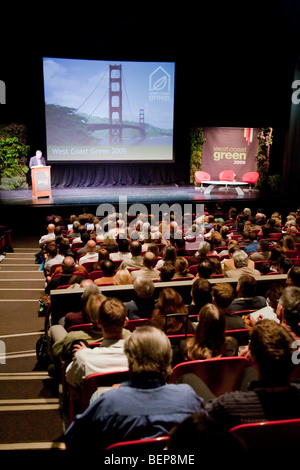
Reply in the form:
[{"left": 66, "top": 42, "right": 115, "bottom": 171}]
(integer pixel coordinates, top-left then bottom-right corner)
[{"left": 0, "top": 239, "right": 63, "bottom": 450}]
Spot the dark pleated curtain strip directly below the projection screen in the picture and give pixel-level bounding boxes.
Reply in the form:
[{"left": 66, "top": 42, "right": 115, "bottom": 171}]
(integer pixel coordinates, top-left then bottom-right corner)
[{"left": 51, "top": 163, "right": 185, "bottom": 188}]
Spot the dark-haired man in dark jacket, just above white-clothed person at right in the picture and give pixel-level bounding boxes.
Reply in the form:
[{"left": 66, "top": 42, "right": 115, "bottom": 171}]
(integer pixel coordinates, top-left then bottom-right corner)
[{"left": 228, "top": 274, "right": 267, "bottom": 313}]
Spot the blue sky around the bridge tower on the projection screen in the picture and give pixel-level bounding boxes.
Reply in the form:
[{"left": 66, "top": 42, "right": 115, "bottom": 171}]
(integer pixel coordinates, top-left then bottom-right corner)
[{"left": 43, "top": 58, "right": 175, "bottom": 129}]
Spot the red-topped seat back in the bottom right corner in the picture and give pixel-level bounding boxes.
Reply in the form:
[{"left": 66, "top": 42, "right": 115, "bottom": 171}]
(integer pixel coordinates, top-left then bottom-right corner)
[{"left": 230, "top": 418, "right": 300, "bottom": 454}]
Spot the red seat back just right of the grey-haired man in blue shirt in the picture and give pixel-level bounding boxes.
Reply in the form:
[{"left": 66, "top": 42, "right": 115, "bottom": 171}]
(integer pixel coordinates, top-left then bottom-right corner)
[{"left": 168, "top": 356, "right": 249, "bottom": 397}]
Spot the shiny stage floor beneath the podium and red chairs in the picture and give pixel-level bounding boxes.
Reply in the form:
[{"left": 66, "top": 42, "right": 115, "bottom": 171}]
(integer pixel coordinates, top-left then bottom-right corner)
[{"left": 0, "top": 185, "right": 260, "bottom": 207}]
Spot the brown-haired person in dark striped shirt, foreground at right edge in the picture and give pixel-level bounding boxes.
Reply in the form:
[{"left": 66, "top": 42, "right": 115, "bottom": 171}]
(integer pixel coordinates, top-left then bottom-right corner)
[{"left": 206, "top": 319, "right": 300, "bottom": 429}]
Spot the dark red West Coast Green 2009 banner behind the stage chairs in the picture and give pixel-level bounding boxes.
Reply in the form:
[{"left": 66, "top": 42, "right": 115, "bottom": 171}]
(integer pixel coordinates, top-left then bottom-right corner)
[{"left": 202, "top": 127, "right": 259, "bottom": 181}]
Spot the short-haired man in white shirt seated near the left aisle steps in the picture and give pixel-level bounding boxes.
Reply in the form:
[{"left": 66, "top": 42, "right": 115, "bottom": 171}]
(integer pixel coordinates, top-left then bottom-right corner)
[{"left": 66, "top": 298, "right": 128, "bottom": 387}]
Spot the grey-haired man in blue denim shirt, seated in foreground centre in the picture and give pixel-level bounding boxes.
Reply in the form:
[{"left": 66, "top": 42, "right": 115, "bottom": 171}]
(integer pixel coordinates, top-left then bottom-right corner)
[{"left": 65, "top": 326, "right": 204, "bottom": 455}]
